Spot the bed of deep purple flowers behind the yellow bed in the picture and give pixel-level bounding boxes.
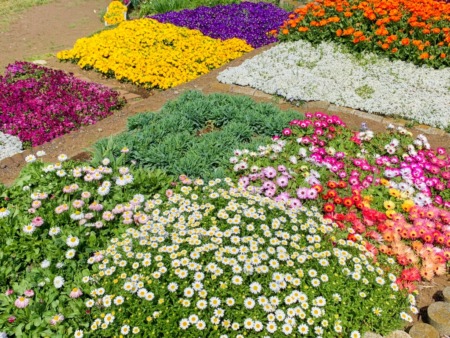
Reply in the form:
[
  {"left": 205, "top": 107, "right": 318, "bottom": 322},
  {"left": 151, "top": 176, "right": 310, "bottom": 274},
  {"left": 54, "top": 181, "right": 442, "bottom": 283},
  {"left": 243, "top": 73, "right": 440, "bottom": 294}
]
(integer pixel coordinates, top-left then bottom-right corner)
[{"left": 152, "top": 2, "right": 287, "bottom": 48}]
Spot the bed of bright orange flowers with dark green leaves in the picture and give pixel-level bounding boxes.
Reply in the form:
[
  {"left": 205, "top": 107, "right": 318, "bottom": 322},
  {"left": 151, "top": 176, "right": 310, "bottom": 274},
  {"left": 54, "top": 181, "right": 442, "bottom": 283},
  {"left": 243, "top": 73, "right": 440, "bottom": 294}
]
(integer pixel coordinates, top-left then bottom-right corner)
[{"left": 278, "top": 0, "right": 450, "bottom": 68}]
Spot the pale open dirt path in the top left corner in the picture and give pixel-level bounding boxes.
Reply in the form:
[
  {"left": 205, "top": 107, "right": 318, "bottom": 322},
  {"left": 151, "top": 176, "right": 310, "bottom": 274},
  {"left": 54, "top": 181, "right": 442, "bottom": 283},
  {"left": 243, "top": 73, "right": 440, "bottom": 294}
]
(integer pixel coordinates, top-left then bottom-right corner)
[{"left": 0, "top": 0, "right": 110, "bottom": 74}]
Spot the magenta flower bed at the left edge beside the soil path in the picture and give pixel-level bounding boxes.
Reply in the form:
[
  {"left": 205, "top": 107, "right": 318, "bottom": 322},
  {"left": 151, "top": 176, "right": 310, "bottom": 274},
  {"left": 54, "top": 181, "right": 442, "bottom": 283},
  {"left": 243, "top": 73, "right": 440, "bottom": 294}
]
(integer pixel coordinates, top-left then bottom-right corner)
[{"left": 0, "top": 62, "right": 125, "bottom": 147}]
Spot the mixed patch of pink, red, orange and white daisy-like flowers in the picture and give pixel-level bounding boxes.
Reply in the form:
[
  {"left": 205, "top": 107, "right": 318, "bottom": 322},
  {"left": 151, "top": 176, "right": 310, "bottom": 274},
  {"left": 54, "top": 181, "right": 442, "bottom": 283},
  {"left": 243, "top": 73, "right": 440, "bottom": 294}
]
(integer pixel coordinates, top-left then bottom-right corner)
[{"left": 230, "top": 112, "right": 450, "bottom": 279}]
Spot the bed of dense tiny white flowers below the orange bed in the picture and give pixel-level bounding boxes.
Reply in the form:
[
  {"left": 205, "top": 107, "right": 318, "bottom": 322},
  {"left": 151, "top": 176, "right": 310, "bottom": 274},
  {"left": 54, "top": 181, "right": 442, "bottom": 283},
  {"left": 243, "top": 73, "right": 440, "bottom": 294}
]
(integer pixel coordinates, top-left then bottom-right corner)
[{"left": 218, "top": 40, "right": 450, "bottom": 128}]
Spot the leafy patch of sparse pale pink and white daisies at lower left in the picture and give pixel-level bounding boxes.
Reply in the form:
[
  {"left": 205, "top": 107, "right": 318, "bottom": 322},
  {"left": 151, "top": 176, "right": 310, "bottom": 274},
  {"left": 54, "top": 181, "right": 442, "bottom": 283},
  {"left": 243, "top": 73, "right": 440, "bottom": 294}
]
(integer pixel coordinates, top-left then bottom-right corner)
[{"left": 0, "top": 152, "right": 172, "bottom": 337}]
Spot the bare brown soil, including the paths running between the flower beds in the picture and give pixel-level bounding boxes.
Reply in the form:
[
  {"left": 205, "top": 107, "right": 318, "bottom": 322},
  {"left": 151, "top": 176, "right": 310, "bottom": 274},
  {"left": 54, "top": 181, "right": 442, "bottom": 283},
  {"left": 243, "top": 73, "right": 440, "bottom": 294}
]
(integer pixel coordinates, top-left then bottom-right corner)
[{"left": 0, "top": 0, "right": 450, "bottom": 332}]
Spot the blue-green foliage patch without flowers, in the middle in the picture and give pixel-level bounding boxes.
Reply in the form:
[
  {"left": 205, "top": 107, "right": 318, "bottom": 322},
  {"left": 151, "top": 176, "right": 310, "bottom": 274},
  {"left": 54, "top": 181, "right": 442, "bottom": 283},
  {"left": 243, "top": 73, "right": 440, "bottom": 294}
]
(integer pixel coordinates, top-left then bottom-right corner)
[{"left": 94, "top": 91, "right": 302, "bottom": 179}]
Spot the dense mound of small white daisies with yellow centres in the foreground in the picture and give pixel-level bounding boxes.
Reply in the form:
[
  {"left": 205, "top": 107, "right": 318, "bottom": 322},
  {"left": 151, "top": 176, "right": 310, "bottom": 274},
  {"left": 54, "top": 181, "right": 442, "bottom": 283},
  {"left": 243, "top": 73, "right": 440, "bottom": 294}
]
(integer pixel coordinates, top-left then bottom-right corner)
[{"left": 83, "top": 179, "right": 417, "bottom": 337}]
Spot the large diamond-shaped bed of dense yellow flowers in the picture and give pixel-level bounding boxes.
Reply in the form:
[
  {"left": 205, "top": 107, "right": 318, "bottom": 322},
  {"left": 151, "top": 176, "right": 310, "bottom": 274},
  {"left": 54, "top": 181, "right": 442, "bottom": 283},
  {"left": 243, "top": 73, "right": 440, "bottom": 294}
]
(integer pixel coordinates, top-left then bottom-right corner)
[{"left": 57, "top": 19, "right": 253, "bottom": 89}]
